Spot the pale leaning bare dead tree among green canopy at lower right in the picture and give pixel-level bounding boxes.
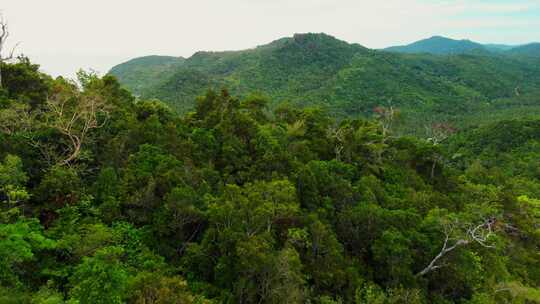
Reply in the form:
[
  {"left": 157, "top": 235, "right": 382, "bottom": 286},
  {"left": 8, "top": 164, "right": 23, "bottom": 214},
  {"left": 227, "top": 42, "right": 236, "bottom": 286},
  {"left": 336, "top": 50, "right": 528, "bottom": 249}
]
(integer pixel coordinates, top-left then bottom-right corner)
[{"left": 416, "top": 218, "right": 496, "bottom": 276}]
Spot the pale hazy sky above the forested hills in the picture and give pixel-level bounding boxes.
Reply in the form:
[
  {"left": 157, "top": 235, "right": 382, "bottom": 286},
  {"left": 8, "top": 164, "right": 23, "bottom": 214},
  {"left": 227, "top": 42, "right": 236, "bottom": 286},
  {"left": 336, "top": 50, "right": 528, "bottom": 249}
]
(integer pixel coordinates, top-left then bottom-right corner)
[{"left": 0, "top": 0, "right": 540, "bottom": 76}]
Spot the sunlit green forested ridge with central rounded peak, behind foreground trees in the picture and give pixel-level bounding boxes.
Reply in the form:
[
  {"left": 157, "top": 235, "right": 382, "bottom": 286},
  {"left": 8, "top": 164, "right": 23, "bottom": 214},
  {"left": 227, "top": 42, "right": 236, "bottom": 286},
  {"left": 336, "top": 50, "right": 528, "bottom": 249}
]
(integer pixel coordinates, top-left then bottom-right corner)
[{"left": 111, "top": 34, "right": 540, "bottom": 132}]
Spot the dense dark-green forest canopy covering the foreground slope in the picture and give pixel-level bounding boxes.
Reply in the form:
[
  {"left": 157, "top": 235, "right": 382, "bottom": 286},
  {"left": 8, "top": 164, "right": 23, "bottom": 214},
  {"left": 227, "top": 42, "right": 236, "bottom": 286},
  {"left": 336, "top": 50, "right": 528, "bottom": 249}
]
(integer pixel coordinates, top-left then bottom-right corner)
[{"left": 0, "top": 58, "right": 540, "bottom": 304}]
